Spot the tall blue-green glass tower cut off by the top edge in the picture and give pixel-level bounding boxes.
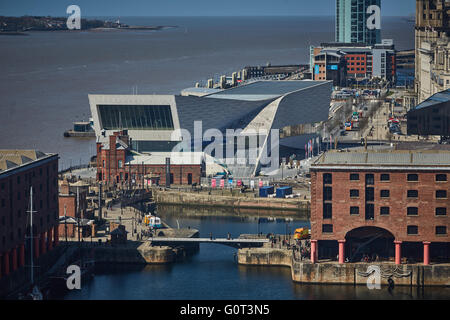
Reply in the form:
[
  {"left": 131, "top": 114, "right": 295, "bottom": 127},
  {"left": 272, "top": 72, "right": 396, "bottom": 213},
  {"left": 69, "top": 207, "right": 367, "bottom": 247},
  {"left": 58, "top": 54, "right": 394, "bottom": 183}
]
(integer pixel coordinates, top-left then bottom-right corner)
[{"left": 336, "top": 0, "right": 381, "bottom": 45}]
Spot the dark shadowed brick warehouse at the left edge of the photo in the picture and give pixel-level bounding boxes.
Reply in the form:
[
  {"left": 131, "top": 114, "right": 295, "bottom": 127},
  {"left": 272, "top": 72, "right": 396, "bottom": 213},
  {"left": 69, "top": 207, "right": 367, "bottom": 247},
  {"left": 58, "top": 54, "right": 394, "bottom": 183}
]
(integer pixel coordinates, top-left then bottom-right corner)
[{"left": 0, "top": 150, "right": 59, "bottom": 278}]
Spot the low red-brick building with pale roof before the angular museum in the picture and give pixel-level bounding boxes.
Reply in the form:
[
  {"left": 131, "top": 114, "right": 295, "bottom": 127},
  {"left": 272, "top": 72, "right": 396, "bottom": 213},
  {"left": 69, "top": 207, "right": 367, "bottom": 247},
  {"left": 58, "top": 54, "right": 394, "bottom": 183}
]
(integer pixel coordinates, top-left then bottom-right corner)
[{"left": 97, "top": 130, "right": 205, "bottom": 186}]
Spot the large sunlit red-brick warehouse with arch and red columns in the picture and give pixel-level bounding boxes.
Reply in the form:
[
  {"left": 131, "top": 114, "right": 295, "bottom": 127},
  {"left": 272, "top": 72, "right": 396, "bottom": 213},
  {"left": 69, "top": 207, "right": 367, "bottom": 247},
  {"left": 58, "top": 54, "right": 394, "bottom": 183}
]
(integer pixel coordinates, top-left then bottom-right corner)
[{"left": 311, "top": 150, "right": 450, "bottom": 265}]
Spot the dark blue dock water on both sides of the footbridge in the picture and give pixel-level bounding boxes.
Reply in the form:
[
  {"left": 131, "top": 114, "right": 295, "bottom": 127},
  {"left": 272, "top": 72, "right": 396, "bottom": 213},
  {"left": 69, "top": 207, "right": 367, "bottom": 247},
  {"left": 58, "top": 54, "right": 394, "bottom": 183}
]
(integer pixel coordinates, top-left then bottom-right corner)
[{"left": 65, "top": 210, "right": 450, "bottom": 300}]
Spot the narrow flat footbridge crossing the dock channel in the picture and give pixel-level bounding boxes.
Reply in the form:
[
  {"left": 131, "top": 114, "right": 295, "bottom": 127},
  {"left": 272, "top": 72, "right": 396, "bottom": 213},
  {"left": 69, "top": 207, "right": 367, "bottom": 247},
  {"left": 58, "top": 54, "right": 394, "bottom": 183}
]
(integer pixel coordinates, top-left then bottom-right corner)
[{"left": 149, "top": 237, "right": 270, "bottom": 249}]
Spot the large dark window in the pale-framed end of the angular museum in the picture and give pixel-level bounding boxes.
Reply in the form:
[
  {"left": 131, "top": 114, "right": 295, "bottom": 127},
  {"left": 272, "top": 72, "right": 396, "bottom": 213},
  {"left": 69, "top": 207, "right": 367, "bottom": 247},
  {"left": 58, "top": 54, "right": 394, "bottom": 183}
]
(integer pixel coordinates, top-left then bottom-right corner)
[{"left": 97, "top": 105, "right": 174, "bottom": 130}]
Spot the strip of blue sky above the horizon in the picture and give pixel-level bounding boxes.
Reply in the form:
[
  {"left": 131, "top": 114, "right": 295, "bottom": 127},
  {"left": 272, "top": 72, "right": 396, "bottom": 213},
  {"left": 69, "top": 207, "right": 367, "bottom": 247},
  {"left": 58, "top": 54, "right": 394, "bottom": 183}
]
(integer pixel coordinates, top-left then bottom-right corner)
[{"left": 0, "top": 0, "right": 416, "bottom": 17}]
